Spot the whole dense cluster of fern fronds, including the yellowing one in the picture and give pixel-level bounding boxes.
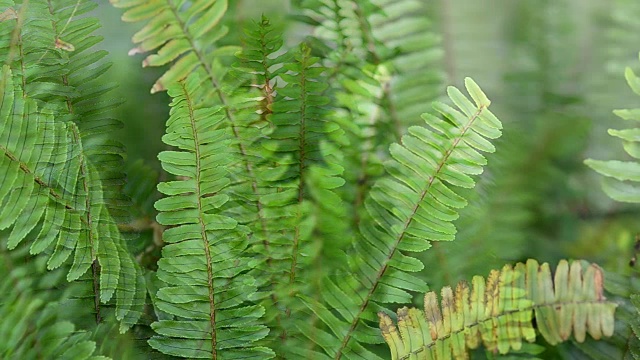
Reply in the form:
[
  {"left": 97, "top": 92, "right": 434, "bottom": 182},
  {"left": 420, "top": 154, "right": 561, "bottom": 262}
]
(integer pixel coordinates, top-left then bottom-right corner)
[{"left": 0, "top": 0, "right": 632, "bottom": 359}]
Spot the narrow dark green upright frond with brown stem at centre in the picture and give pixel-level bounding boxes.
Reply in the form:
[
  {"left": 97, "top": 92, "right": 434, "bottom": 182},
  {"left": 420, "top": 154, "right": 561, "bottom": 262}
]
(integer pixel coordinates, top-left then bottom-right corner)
[{"left": 262, "top": 44, "right": 344, "bottom": 268}]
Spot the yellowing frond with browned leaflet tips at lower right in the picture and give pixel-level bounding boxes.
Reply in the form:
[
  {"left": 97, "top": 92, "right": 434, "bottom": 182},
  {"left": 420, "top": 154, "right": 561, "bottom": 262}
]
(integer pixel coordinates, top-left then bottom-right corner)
[{"left": 378, "top": 260, "right": 617, "bottom": 360}]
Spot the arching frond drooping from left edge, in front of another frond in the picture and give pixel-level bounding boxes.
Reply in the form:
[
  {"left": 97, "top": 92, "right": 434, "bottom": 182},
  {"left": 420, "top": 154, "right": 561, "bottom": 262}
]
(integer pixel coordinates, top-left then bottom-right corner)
[{"left": 0, "top": 59, "right": 144, "bottom": 338}]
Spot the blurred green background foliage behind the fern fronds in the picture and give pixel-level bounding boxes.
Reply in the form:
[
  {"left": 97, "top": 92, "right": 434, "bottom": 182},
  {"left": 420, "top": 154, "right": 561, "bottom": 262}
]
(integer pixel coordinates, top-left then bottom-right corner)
[{"left": 0, "top": 0, "right": 640, "bottom": 359}]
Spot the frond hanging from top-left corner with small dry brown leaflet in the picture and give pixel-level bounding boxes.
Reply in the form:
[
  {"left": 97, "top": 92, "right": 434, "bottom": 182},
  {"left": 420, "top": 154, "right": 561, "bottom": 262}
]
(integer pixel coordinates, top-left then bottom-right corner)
[{"left": 0, "top": 0, "right": 134, "bottom": 236}]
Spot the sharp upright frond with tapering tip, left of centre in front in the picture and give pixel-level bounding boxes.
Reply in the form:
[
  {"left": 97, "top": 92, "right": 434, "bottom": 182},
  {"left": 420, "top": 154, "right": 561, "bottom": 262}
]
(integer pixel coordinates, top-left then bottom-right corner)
[{"left": 149, "top": 74, "right": 273, "bottom": 359}]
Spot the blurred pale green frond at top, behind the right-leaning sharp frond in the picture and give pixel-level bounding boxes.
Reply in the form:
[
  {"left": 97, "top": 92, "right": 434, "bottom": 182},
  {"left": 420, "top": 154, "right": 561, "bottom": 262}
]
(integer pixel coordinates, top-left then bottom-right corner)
[{"left": 294, "top": 0, "right": 442, "bottom": 228}]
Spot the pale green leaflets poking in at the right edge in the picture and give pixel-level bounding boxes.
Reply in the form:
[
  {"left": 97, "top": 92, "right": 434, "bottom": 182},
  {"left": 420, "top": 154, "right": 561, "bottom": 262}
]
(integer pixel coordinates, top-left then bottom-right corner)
[{"left": 585, "top": 60, "right": 640, "bottom": 203}]
